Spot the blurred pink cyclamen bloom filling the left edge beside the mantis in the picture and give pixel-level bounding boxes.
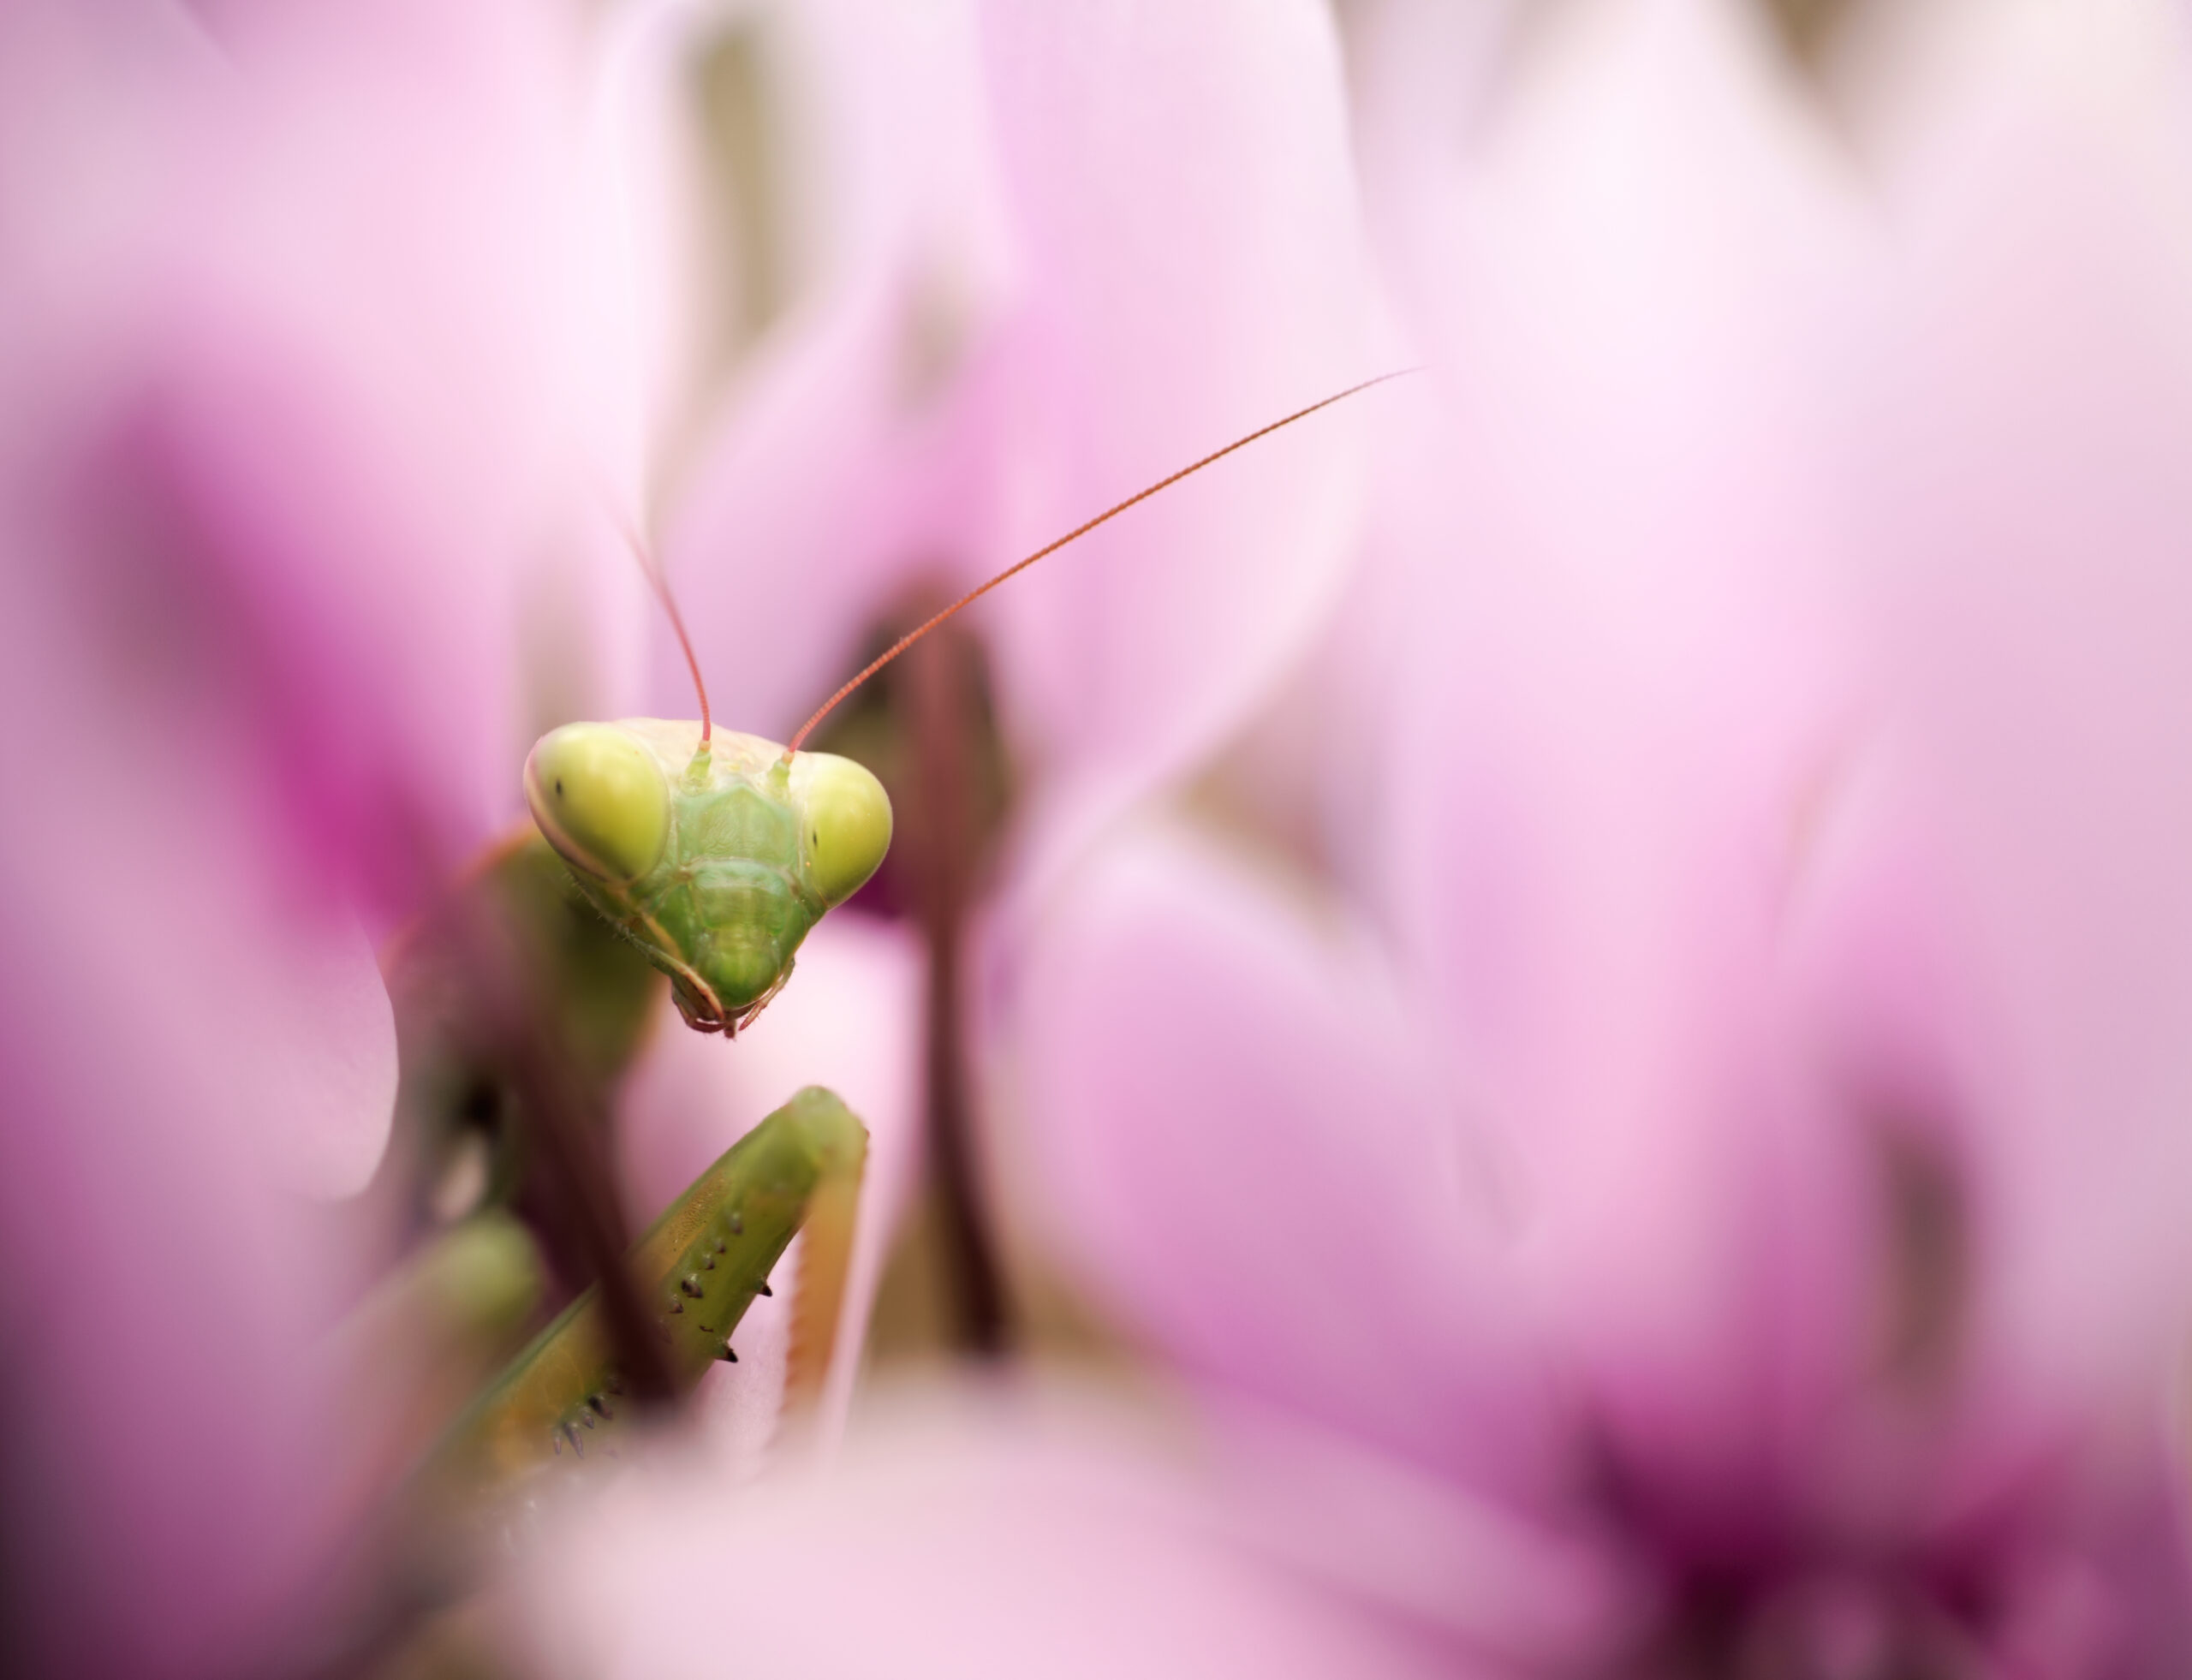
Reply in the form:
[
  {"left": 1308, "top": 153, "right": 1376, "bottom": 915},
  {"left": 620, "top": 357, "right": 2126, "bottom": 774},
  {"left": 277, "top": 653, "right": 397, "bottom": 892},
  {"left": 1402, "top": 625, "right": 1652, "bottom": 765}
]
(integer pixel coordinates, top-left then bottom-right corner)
[{"left": 0, "top": 3, "right": 658, "bottom": 1676}]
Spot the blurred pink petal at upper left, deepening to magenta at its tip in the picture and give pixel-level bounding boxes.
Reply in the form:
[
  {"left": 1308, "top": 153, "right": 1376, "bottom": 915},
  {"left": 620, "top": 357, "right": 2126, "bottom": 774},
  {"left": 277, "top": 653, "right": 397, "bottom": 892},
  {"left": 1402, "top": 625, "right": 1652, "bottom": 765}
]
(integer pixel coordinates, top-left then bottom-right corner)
[{"left": 0, "top": 7, "right": 629, "bottom": 895}]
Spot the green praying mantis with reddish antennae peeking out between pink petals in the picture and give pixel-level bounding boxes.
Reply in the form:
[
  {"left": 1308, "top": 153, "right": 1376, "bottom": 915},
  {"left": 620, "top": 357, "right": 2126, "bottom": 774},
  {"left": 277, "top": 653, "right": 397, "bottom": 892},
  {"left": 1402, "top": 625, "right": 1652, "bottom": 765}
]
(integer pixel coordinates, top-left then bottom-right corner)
[{"left": 436, "top": 371, "right": 1405, "bottom": 1493}]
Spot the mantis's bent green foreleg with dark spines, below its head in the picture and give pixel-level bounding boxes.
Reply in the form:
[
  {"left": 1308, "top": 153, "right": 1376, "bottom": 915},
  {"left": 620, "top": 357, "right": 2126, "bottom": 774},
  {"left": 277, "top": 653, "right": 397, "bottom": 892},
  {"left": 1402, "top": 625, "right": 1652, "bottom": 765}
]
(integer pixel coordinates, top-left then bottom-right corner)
[{"left": 427, "top": 1086, "right": 868, "bottom": 1498}]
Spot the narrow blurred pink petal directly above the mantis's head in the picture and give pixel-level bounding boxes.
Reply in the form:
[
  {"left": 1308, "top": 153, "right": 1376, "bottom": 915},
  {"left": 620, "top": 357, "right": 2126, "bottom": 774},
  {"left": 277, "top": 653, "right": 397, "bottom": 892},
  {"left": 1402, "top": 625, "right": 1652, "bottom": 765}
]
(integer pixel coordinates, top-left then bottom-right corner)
[{"left": 655, "top": 4, "right": 1010, "bottom": 735}]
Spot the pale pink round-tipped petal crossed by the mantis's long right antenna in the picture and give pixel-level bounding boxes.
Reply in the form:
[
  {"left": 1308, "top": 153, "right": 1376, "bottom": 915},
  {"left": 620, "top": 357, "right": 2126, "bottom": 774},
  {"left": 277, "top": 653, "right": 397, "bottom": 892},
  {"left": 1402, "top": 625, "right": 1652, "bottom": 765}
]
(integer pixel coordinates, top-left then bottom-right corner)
[{"left": 986, "top": 0, "right": 1383, "bottom": 798}]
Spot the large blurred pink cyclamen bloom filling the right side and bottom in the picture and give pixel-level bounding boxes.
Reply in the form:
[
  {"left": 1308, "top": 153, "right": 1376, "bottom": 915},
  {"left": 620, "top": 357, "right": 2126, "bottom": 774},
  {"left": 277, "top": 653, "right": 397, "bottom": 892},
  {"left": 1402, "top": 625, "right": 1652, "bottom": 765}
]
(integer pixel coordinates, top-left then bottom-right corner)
[{"left": 535, "top": 0, "right": 2192, "bottom": 1676}]
